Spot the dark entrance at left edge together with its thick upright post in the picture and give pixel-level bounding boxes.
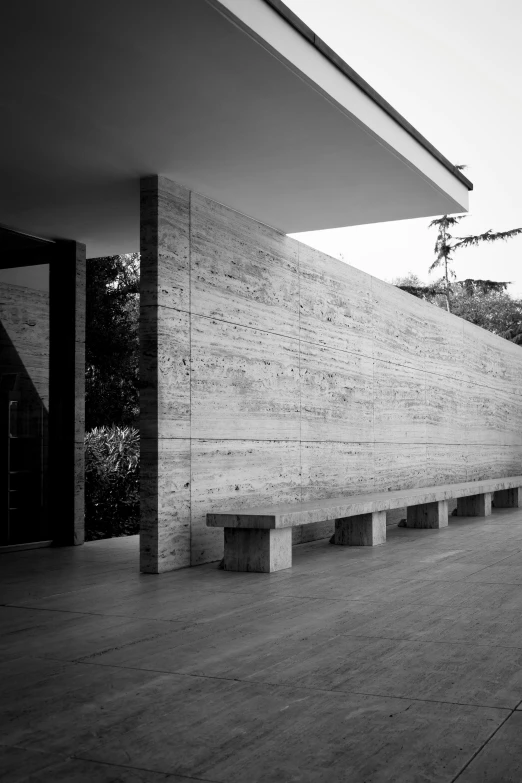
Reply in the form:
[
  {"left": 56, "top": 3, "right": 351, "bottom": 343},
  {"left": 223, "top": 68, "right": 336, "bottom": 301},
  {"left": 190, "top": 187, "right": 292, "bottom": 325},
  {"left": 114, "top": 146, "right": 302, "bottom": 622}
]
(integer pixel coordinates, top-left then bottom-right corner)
[{"left": 0, "top": 227, "right": 85, "bottom": 551}]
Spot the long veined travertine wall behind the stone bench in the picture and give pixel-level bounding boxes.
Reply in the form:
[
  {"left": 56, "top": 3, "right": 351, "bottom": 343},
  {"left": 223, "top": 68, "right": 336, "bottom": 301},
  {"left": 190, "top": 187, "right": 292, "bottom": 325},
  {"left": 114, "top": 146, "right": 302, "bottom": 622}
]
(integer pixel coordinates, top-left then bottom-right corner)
[{"left": 141, "top": 178, "right": 522, "bottom": 571}]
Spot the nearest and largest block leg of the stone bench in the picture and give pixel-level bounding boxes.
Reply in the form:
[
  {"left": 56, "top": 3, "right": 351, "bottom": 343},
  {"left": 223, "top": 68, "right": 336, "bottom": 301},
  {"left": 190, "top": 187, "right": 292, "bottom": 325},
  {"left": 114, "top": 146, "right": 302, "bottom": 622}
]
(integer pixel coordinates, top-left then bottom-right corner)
[{"left": 223, "top": 527, "right": 292, "bottom": 574}]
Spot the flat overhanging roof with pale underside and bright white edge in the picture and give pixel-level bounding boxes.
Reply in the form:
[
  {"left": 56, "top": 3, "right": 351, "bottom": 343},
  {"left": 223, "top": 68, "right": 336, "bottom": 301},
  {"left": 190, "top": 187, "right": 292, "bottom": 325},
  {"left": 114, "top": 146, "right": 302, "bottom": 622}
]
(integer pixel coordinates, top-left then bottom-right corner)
[{"left": 0, "top": 0, "right": 472, "bottom": 257}]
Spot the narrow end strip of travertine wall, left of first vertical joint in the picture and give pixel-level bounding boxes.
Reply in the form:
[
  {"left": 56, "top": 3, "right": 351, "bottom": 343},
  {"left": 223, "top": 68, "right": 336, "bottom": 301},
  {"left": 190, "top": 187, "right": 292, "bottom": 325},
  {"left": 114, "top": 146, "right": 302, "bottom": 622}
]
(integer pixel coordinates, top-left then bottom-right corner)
[{"left": 140, "top": 176, "right": 190, "bottom": 573}]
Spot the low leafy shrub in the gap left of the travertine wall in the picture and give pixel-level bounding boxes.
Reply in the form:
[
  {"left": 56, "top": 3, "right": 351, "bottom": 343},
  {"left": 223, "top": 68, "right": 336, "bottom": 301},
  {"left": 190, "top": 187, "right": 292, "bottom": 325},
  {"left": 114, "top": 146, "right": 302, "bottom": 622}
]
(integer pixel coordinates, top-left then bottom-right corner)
[{"left": 85, "top": 426, "right": 140, "bottom": 541}]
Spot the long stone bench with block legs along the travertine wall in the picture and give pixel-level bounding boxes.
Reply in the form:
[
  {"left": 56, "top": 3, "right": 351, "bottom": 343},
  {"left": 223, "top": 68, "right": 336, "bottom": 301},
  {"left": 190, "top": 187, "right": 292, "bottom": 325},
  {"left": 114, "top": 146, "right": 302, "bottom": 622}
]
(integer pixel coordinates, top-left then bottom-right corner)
[{"left": 207, "top": 476, "right": 522, "bottom": 573}]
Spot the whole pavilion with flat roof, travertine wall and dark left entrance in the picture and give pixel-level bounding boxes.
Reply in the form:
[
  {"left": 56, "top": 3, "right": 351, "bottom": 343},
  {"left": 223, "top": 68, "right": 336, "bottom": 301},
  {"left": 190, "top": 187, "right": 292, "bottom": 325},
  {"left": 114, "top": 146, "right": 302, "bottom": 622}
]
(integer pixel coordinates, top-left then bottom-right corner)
[{"left": 0, "top": 0, "right": 480, "bottom": 572}]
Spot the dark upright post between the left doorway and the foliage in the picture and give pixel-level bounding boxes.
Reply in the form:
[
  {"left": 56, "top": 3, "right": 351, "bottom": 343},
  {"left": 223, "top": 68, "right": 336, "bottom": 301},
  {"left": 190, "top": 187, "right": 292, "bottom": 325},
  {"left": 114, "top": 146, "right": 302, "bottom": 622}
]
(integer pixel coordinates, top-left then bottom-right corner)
[{"left": 49, "top": 242, "right": 86, "bottom": 545}]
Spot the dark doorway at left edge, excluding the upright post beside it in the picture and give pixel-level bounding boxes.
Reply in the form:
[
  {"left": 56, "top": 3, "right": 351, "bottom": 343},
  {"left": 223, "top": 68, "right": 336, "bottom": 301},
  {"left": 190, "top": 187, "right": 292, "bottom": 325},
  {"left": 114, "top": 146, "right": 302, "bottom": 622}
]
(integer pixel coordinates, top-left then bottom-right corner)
[{"left": 0, "top": 229, "right": 52, "bottom": 546}]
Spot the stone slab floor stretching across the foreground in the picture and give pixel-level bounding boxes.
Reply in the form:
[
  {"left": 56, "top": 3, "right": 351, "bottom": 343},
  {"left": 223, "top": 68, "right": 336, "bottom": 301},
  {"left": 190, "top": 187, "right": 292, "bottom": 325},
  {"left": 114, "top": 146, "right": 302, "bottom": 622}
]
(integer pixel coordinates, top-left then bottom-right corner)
[{"left": 0, "top": 510, "right": 522, "bottom": 783}]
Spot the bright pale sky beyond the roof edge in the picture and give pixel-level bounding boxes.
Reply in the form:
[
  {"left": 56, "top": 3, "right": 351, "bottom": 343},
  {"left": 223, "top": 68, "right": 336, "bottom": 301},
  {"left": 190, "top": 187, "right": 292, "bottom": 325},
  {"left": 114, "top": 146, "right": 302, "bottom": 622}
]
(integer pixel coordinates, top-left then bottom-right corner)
[{"left": 285, "top": 0, "right": 522, "bottom": 298}]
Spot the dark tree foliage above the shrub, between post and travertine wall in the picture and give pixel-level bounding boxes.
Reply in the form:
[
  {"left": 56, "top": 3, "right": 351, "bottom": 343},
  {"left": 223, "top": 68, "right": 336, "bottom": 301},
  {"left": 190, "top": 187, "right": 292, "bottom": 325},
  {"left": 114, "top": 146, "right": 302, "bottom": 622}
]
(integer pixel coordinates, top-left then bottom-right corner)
[{"left": 85, "top": 253, "right": 139, "bottom": 430}]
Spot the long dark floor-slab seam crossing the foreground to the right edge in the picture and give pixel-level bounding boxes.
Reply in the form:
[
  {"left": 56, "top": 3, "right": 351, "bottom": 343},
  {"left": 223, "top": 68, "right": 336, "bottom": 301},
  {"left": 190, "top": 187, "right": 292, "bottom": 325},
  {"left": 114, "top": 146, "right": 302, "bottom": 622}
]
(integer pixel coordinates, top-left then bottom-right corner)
[{"left": 70, "top": 661, "right": 520, "bottom": 712}]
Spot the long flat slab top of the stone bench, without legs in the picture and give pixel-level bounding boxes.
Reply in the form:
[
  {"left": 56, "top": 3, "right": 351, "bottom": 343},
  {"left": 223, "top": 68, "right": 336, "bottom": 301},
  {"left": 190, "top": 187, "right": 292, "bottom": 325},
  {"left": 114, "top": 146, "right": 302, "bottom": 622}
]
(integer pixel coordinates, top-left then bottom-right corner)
[{"left": 207, "top": 476, "right": 522, "bottom": 529}]
